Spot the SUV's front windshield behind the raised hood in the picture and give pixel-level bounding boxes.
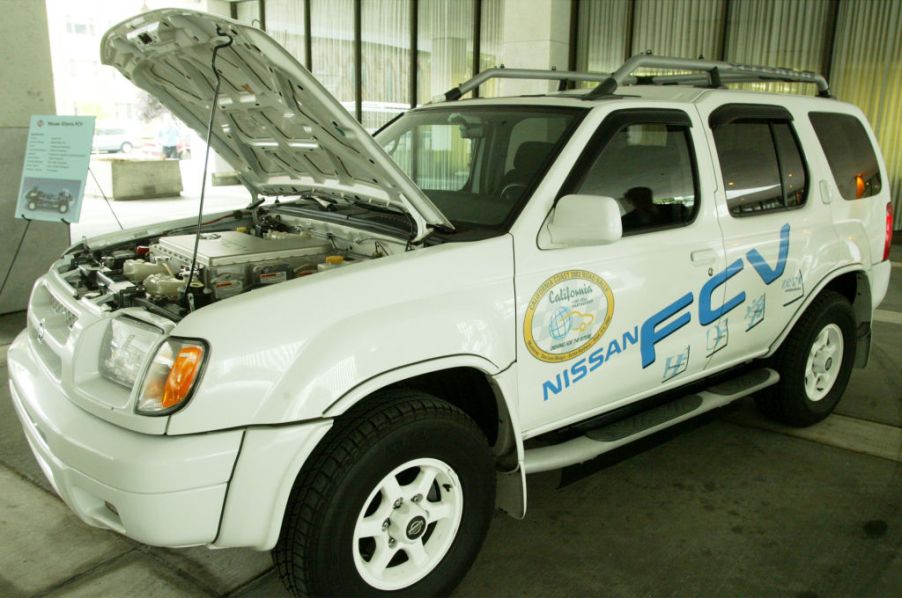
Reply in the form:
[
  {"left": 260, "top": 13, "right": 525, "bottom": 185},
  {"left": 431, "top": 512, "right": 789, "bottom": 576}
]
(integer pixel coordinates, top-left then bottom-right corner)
[{"left": 376, "top": 106, "right": 586, "bottom": 228}]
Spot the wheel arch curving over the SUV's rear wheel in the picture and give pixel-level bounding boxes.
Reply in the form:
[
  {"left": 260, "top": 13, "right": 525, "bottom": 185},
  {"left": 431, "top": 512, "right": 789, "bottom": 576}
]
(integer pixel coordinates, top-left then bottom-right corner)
[{"left": 766, "top": 264, "right": 874, "bottom": 368}]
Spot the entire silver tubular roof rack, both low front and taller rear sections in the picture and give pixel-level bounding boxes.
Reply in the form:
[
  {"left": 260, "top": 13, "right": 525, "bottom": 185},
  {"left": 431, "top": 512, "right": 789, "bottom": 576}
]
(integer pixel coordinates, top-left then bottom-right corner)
[{"left": 433, "top": 53, "right": 831, "bottom": 102}]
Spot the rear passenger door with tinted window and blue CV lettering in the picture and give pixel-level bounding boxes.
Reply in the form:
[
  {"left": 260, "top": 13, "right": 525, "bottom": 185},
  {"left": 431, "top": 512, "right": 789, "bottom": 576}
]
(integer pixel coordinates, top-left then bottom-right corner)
[{"left": 701, "top": 104, "right": 835, "bottom": 369}]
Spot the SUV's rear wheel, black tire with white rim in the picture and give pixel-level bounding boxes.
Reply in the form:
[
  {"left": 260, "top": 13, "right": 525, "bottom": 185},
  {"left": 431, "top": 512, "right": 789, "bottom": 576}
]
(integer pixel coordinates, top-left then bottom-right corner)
[{"left": 755, "top": 291, "right": 855, "bottom": 427}]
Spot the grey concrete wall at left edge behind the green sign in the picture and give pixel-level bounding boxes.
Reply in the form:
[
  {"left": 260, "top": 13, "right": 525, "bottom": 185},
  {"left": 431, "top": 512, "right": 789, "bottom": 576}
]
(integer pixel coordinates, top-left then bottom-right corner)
[{"left": 0, "top": 0, "right": 69, "bottom": 313}]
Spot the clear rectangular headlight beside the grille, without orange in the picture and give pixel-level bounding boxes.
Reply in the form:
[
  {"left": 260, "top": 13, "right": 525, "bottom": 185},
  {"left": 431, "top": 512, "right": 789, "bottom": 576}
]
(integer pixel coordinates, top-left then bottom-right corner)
[{"left": 99, "top": 318, "right": 162, "bottom": 390}]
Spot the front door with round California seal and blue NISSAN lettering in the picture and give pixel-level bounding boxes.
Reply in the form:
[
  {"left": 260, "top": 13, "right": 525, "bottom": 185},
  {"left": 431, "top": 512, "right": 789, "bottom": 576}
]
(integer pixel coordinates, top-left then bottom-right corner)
[{"left": 516, "top": 109, "right": 724, "bottom": 435}]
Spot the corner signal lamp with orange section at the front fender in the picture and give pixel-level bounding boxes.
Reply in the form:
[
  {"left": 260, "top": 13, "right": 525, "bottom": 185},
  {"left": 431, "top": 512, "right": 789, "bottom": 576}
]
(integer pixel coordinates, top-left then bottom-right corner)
[{"left": 135, "top": 338, "right": 207, "bottom": 415}]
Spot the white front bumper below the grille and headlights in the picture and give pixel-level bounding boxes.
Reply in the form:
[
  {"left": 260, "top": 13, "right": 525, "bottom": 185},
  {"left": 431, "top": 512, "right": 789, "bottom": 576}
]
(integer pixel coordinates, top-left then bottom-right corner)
[{"left": 7, "top": 333, "right": 244, "bottom": 546}]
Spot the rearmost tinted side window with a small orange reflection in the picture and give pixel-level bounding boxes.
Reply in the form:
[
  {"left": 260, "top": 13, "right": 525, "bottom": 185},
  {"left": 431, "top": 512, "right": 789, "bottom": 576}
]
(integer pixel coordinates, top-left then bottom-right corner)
[{"left": 808, "top": 112, "right": 882, "bottom": 199}]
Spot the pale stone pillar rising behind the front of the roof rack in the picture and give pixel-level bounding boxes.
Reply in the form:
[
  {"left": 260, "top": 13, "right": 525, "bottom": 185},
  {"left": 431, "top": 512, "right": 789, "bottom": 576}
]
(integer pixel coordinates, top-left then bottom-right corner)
[{"left": 501, "top": 0, "right": 570, "bottom": 95}]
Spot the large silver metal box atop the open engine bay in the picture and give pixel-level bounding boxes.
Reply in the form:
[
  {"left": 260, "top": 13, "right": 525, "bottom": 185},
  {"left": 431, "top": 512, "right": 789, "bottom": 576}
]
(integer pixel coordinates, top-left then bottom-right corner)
[{"left": 150, "top": 231, "right": 331, "bottom": 299}]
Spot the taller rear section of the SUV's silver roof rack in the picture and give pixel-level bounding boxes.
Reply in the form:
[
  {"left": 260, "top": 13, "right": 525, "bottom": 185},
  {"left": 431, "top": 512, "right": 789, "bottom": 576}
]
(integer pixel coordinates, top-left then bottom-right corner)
[{"left": 586, "top": 54, "right": 830, "bottom": 99}]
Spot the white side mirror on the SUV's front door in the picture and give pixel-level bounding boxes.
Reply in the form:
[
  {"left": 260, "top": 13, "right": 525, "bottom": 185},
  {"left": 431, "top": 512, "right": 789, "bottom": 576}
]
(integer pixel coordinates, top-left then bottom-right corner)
[{"left": 548, "top": 195, "right": 623, "bottom": 247}]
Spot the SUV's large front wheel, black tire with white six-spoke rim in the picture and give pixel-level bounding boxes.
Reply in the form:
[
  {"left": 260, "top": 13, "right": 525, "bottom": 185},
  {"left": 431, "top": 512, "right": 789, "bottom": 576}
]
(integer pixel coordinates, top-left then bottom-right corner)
[{"left": 272, "top": 391, "right": 495, "bottom": 596}]
